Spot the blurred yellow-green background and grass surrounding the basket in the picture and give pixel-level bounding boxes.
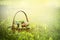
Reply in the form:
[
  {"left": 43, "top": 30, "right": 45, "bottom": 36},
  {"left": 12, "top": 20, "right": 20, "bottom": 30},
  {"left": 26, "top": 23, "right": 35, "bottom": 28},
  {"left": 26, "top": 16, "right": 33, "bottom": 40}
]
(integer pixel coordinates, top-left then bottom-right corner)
[{"left": 0, "top": 0, "right": 60, "bottom": 40}]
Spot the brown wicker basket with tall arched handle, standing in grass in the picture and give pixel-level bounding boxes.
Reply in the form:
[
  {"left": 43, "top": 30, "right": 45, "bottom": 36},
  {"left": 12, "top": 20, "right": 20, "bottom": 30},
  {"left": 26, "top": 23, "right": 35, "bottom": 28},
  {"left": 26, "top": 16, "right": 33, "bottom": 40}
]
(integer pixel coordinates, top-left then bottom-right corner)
[{"left": 11, "top": 10, "right": 30, "bottom": 32}]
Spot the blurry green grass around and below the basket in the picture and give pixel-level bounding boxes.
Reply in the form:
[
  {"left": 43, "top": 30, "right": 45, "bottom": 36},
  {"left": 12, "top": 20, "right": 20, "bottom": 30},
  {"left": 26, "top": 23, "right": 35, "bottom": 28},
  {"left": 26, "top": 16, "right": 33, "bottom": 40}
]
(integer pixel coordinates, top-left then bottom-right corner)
[{"left": 0, "top": 21, "right": 60, "bottom": 40}]
